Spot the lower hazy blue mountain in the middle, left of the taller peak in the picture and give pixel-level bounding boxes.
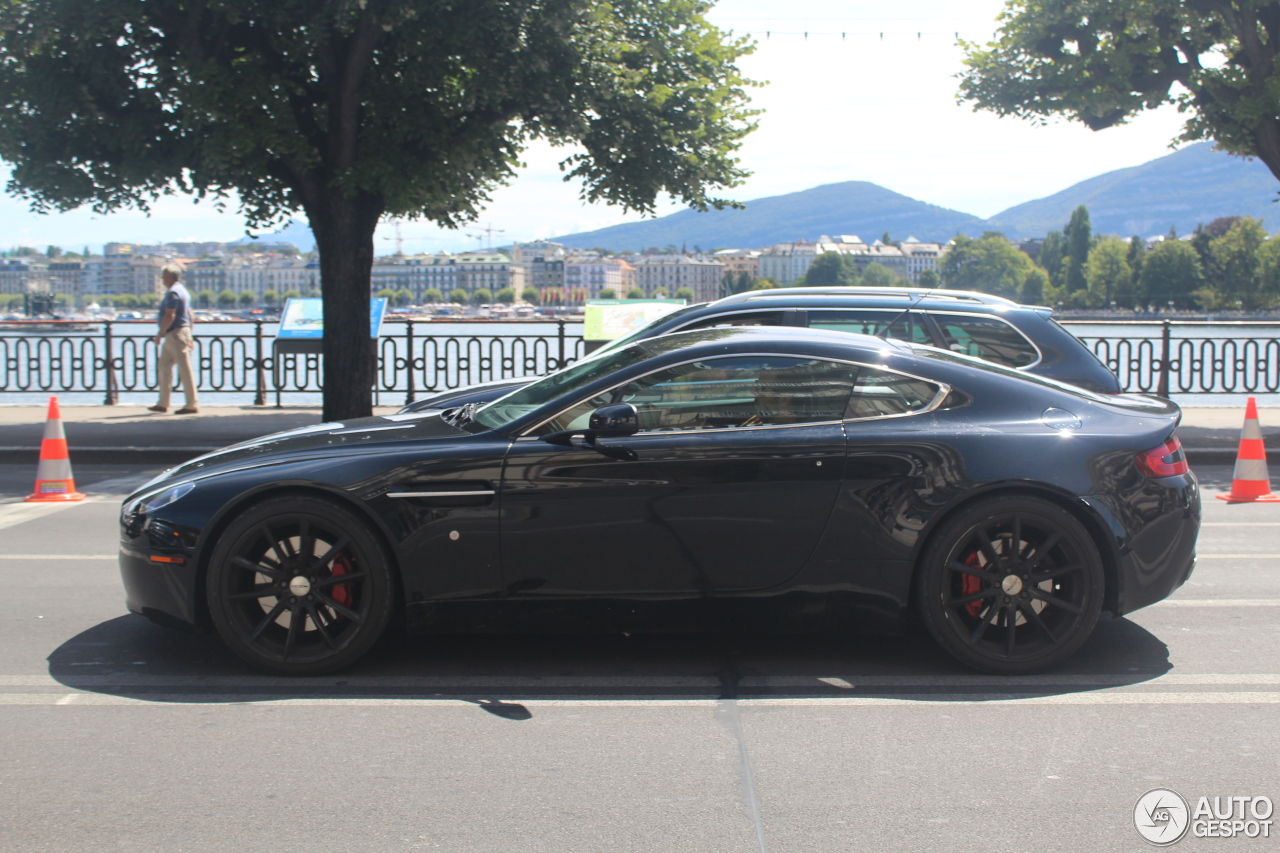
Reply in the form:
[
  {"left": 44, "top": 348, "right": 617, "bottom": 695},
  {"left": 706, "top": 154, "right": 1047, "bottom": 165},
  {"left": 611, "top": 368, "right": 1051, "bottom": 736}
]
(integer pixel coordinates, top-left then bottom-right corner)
[{"left": 553, "top": 181, "right": 988, "bottom": 251}]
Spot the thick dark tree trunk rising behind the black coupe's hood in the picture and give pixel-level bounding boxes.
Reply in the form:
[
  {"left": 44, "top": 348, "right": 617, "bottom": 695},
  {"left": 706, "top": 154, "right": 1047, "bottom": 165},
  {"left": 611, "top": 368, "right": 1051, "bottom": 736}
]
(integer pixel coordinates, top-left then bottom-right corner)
[{"left": 307, "top": 190, "right": 383, "bottom": 421}]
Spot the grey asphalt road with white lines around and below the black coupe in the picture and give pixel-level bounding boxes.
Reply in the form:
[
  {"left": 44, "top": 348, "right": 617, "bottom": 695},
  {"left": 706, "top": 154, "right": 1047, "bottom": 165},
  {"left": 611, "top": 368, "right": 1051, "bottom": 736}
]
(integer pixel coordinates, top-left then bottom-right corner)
[{"left": 0, "top": 465, "right": 1280, "bottom": 853}]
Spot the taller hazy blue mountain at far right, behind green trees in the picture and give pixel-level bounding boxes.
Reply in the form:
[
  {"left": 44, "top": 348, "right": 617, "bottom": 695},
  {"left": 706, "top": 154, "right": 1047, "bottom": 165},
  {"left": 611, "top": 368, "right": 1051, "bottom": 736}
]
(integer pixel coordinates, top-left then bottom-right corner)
[{"left": 991, "top": 142, "right": 1280, "bottom": 237}]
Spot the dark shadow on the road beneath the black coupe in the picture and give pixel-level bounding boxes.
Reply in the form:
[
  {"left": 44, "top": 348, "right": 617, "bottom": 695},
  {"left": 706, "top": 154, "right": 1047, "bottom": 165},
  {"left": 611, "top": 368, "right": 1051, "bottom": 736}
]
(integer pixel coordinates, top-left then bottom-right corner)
[{"left": 47, "top": 616, "right": 1171, "bottom": 701}]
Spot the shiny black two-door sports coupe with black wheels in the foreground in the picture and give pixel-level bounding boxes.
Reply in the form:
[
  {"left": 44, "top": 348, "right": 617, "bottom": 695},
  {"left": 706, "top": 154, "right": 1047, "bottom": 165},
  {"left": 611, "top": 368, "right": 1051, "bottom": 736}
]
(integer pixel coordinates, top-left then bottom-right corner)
[{"left": 120, "top": 328, "right": 1201, "bottom": 674}]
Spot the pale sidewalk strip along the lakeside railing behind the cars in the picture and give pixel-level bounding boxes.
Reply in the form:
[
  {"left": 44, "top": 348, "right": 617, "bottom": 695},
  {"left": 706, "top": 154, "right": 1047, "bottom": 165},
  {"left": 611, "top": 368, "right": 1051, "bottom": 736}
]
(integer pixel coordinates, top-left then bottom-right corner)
[{"left": 0, "top": 405, "right": 1280, "bottom": 465}]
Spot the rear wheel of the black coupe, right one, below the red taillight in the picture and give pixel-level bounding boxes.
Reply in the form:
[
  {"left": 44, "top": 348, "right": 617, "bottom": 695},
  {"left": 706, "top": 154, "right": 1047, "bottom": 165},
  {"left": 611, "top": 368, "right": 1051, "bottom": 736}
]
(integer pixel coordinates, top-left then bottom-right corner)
[{"left": 916, "top": 496, "right": 1106, "bottom": 675}]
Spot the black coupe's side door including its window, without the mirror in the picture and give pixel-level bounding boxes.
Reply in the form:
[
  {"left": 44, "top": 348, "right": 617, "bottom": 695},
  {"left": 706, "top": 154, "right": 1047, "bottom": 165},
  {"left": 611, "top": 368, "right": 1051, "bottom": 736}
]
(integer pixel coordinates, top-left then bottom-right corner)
[{"left": 500, "top": 355, "right": 858, "bottom": 596}]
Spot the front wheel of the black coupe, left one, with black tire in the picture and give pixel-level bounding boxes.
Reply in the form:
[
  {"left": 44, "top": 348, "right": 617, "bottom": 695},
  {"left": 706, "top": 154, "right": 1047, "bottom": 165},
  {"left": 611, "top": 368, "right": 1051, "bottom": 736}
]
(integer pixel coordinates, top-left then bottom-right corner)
[{"left": 205, "top": 496, "right": 394, "bottom": 675}]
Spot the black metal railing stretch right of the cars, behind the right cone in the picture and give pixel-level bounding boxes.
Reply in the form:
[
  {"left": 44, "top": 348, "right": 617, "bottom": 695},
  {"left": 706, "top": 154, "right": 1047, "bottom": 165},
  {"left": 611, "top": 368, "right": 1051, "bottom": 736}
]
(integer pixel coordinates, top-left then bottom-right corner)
[{"left": 1062, "top": 320, "right": 1280, "bottom": 397}]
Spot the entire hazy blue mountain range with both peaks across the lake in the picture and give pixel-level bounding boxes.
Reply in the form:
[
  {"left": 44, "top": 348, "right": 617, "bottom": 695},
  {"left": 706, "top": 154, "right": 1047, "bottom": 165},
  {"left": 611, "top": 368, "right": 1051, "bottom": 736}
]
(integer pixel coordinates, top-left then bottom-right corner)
[{"left": 553, "top": 142, "right": 1280, "bottom": 251}]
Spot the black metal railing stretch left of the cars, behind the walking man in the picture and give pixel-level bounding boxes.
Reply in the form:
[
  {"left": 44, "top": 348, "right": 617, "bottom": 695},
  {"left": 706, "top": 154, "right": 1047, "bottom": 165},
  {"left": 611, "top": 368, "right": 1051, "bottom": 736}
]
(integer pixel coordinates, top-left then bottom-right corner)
[{"left": 0, "top": 320, "right": 584, "bottom": 406}]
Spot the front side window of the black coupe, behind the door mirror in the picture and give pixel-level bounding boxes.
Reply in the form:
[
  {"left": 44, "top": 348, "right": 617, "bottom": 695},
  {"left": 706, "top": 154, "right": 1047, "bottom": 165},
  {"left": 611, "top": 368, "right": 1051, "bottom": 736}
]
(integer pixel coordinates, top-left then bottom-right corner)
[{"left": 539, "top": 356, "right": 859, "bottom": 434}]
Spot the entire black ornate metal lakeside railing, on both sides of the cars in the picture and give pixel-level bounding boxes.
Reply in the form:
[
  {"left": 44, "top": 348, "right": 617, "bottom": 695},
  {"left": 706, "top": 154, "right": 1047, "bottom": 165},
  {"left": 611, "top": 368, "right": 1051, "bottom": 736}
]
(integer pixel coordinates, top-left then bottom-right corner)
[{"left": 0, "top": 320, "right": 1280, "bottom": 406}]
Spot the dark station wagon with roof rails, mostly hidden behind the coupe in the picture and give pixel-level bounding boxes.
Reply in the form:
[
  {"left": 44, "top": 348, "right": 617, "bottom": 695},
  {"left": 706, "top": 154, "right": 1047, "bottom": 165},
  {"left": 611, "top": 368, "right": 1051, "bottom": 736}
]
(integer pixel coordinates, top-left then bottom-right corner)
[{"left": 401, "top": 287, "right": 1120, "bottom": 412}]
